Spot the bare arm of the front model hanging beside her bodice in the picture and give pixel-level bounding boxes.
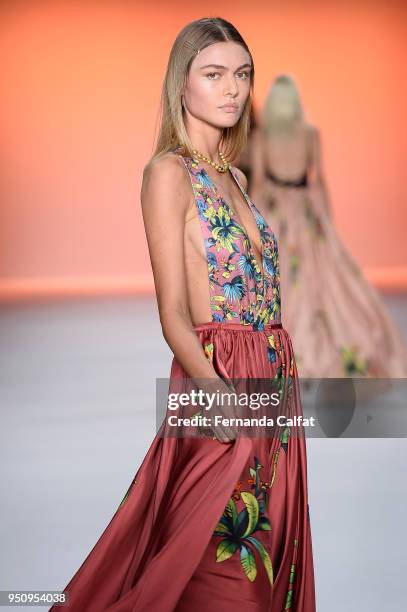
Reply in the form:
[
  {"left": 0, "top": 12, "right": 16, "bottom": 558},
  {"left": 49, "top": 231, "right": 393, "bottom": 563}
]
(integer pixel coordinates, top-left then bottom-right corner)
[{"left": 141, "top": 153, "right": 234, "bottom": 441}]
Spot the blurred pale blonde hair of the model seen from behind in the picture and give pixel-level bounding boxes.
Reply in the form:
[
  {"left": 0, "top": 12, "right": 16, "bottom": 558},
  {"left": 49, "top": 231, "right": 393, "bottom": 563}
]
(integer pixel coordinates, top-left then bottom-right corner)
[{"left": 262, "top": 74, "right": 305, "bottom": 134}]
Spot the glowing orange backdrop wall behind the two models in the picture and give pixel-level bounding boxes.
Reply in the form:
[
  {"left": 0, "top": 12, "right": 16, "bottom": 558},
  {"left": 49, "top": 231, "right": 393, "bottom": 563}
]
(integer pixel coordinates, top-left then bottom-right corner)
[{"left": 0, "top": 0, "right": 407, "bottom": 298}]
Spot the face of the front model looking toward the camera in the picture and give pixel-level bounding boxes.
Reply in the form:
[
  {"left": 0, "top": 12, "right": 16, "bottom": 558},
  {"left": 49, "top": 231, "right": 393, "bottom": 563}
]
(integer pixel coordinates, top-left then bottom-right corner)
[{"left": 184, "top": 41, "right": 252, "bottom": 128}]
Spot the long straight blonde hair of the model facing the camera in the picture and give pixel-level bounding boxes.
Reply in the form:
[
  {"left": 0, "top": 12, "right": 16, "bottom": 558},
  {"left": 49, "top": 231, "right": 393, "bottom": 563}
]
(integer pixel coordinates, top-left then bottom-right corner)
[{"left": 152, "top": 17, "right": 254, "bottom": 160}]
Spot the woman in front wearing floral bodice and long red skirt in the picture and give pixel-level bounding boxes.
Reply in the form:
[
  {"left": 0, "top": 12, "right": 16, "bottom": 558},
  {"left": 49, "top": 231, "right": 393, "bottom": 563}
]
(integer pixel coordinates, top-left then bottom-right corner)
[{"left": 51, "top": 18, "right": 315, "bottom": 612}]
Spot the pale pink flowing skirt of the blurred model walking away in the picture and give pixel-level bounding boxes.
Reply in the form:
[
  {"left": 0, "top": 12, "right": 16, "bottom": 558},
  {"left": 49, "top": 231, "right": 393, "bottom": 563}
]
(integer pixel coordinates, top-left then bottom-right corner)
[{"left": 265, "top": 181, "right": 407, "bottom": 378}]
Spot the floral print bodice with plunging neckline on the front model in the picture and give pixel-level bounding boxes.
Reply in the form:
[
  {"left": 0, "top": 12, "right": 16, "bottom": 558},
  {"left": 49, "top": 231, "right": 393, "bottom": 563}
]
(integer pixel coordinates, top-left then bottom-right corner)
[{"left": 179, "top": 155, "right": 281, "bottom": 331}]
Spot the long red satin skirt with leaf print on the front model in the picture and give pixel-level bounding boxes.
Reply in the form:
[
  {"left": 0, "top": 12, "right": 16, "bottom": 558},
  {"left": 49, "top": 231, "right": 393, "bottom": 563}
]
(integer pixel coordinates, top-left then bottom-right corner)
[{"left": 51, "top": 322, "right": 316, "bottom": 612}]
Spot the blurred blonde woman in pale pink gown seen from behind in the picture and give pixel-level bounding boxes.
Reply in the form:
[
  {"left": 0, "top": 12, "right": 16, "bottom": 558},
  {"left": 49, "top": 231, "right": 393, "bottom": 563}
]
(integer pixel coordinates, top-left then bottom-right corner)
[{"left": 250, "top": 75, "right": 407, "bottom": 379}]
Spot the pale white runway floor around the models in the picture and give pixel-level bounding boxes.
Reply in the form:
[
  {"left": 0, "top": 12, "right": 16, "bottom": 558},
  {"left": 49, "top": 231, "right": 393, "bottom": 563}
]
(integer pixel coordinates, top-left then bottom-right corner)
[{"left": 0, "top": 295, "right": 407, "bottom": 612}]
